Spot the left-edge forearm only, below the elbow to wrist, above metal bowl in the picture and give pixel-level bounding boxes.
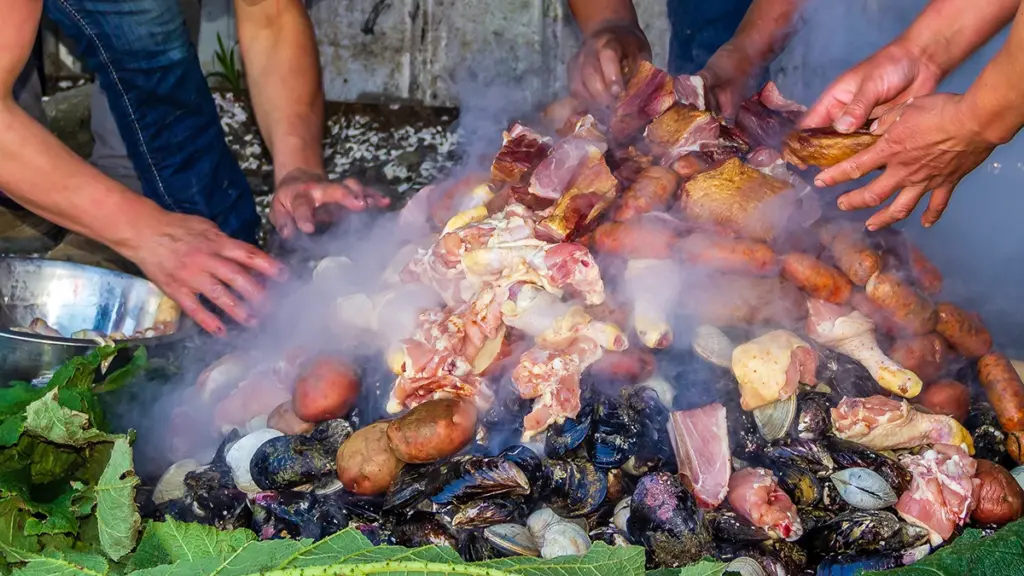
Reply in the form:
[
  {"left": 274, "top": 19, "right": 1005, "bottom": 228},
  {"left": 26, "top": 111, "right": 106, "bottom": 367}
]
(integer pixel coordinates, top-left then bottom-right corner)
[{"left": 0, "top": 98, "right": 163, "bottom": 256}]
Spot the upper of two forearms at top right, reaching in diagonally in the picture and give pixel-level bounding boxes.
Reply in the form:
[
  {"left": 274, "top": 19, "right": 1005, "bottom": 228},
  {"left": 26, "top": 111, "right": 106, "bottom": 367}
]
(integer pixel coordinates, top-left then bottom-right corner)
[{"left": 896, "top": 0, "right": 1021, "bottom": 77}]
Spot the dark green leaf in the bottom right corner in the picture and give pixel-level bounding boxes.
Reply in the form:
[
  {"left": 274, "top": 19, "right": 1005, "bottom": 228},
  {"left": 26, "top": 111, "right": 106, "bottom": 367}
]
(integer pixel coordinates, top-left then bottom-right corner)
[{"left": 864, "top": 520, "right": 1024, "bottom": 576}]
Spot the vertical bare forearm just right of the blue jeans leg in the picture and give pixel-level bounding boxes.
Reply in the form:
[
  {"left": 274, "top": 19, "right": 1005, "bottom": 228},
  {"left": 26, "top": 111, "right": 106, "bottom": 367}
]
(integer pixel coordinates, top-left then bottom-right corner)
[{"left": 237, "top": 0, "right": 324, "bottom": 180}]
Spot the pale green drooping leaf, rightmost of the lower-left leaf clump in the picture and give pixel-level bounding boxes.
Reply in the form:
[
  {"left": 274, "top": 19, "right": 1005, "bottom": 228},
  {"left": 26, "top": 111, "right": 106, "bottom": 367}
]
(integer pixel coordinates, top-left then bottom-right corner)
[{"left": 95, "top": 438, "right": 142, "bottom": 561}]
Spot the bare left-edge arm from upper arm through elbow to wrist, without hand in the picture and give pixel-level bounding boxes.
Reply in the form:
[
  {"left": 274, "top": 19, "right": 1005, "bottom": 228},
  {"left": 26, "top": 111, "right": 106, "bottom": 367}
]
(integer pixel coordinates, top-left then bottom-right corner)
[{"left": 0, "top": 0, "right": 163, "bottom": 255}]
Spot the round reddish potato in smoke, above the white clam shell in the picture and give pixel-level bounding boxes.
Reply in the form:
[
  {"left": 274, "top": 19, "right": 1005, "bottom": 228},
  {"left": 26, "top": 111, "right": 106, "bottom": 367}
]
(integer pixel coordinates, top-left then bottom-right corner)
[{"left": 292, "top": 356, "right": 359, "bottom": 422}]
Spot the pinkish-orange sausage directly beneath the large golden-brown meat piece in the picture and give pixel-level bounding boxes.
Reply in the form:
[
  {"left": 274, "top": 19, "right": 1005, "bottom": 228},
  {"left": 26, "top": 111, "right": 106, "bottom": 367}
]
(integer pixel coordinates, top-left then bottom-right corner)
[{"left": 679, "top": 233, "right": 778, "bottom": 276}]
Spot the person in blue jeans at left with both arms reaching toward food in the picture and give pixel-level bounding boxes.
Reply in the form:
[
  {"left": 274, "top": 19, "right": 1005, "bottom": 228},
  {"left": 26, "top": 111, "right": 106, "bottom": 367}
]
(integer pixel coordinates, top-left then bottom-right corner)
[{"left": 0, "top": 0, "right": 387, "bottom": 334}]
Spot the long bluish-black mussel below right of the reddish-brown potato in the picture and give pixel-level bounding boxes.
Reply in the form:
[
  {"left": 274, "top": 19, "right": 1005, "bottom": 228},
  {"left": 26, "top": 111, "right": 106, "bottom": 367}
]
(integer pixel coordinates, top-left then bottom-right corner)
[{"left": 430, "top": 456, "right": 529, "bottom": 504}]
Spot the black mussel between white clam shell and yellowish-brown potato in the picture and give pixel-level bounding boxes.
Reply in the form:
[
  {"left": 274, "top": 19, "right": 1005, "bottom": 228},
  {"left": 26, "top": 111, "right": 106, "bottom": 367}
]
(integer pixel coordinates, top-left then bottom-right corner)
[{"left": 249, "top": 435, "right": 338, "bottom": 490}]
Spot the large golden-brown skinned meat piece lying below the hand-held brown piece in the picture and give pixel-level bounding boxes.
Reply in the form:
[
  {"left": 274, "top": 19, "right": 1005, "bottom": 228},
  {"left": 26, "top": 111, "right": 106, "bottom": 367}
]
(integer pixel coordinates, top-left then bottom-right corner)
[{"left": 683, "top": 158, "right": 796, "bottom": 241}]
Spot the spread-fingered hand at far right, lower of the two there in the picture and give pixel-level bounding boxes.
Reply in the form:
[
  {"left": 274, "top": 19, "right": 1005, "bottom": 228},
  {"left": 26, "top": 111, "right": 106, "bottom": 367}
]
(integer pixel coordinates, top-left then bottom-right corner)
[{"left": 814, "top": 94, "right": 998, "bottom": 231}]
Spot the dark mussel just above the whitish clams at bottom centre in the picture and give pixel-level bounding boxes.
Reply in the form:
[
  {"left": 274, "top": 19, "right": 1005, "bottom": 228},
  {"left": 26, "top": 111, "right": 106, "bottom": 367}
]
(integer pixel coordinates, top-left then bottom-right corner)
[{"left": 535, "top": 460, "right": 608, "bottom": 518}]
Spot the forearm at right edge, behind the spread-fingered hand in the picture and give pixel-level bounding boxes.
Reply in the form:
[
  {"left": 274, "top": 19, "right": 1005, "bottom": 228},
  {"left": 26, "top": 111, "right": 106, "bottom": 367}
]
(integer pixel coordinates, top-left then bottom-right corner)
[{"left": 961, "top": 2, "right": 1024, "bottom": 145}]
